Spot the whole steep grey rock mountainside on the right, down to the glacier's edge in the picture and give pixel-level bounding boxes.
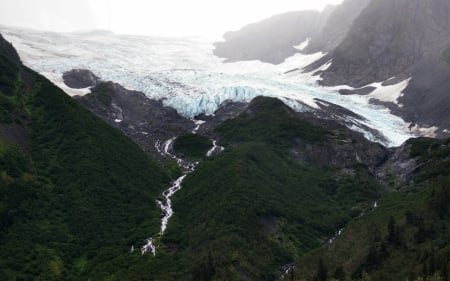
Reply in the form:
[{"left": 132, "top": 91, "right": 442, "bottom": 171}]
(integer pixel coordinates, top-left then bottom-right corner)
[{"left": 322, "top": 0, "right": 450, "bottom": 129}]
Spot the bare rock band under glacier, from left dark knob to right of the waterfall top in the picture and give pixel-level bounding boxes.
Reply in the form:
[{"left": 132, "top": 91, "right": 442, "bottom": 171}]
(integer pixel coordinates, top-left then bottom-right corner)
[{"left": 63, "top": 69, "right": 247, "bottom": 158}]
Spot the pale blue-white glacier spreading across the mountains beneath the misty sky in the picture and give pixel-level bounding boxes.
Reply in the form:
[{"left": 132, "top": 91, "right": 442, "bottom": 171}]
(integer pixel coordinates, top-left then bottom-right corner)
[{"left": 0, "top": 27, "right": 420, "bottom": 146}]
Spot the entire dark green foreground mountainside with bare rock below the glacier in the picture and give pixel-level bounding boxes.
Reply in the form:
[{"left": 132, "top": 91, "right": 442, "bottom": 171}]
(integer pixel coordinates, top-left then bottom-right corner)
[{"left": 0, "top": 30, "right": 450, "bottom": 281}]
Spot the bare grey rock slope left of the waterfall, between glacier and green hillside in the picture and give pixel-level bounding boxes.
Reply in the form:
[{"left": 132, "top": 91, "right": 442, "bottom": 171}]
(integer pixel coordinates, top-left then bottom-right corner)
[{"left": 75, "top": 82, "right": 194, "bottom": 157}]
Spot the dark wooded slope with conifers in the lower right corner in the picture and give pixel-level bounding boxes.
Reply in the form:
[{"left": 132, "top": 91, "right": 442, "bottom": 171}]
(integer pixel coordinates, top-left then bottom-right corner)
[{"left": 287, "top": 139, "right": 450, "bottom": 281}]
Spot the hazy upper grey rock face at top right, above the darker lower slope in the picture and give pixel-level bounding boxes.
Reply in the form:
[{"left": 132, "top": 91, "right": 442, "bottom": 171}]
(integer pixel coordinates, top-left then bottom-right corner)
[{"left": 323, "top": 0, "right": 450, "bottom": 87}]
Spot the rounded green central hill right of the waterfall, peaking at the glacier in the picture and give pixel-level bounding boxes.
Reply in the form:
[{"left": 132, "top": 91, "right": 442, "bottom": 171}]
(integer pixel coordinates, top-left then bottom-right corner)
[{"left": 146, "top": 97, "right": 385, "bottom": 280}]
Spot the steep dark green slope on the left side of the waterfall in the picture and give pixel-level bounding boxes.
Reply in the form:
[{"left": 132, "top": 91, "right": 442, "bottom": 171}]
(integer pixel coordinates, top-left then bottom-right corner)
[{"left": 0, "top": 34, "right": 169, "bottom": 280}]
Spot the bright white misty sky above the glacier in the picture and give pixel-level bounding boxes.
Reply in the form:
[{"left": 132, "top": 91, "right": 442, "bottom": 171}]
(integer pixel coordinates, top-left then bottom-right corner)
[{"left": 0, "top": 0, "right": 342, "bottom": 37}]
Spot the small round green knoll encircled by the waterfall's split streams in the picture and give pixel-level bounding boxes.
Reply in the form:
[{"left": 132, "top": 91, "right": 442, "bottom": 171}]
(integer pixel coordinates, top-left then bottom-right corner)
[{"left": 173, "top": 134, "right": 212, "bottom": 160}]
